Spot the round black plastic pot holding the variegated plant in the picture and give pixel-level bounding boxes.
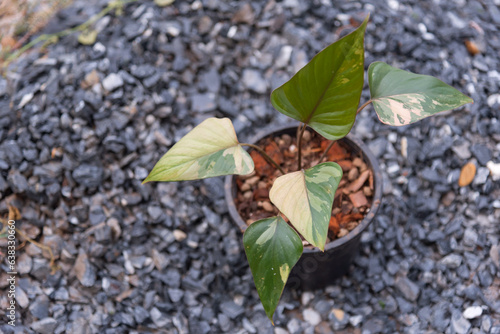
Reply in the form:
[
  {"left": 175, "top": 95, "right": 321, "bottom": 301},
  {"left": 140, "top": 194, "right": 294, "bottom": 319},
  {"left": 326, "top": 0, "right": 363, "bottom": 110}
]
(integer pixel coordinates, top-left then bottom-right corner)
[{"left": 224, "top": 125, "right": 382, "bottom": 290}]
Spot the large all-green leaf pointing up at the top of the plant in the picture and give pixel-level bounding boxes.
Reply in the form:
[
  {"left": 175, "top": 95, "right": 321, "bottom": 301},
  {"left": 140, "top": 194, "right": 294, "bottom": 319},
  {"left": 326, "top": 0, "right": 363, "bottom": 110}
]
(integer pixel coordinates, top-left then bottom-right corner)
[{"left": 271, "top": 17, "right": 368, "bottom": 140}]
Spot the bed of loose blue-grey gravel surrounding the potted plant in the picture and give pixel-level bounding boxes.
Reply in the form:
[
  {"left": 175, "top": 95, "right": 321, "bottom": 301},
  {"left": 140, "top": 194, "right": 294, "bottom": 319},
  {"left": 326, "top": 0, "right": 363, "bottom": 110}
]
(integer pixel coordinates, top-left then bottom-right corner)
[{"left": 0, "top": 0, "right": 500, "bottom": 334}]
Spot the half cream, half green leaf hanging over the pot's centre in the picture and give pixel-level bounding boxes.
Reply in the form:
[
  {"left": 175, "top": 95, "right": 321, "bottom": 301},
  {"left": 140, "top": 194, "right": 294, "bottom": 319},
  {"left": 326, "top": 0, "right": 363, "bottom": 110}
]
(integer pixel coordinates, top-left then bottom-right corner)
[{"left": 269, "top": 162, "right": 342, "bottom": 250}]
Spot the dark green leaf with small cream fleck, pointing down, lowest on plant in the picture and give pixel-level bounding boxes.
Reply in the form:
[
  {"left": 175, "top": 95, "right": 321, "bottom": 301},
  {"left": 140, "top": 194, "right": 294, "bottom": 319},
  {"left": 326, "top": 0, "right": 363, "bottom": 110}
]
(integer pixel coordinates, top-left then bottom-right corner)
[{"left": 243, "top": 216, "right": 303, "bottom": 321}]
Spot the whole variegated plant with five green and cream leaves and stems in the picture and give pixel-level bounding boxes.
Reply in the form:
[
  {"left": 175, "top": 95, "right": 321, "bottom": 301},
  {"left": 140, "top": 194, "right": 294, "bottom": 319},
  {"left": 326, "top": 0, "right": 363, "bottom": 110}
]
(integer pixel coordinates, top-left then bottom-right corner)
[{"left": 144, "top": 17, "right": 472, "bottom": 321}]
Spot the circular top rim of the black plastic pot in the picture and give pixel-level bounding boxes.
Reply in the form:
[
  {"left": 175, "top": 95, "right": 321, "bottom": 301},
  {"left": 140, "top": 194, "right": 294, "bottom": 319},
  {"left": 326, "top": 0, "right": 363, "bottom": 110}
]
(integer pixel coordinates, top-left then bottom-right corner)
[{"left": 224, "top": 123, "right": 382, "bottom": 253}]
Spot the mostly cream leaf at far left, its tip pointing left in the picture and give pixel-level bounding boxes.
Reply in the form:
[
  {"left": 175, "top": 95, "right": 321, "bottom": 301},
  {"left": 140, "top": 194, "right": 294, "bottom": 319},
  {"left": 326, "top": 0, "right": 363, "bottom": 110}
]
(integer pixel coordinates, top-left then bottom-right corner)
[{"left": 143, "top": 117, "right": 254, "bottom": 183}]
